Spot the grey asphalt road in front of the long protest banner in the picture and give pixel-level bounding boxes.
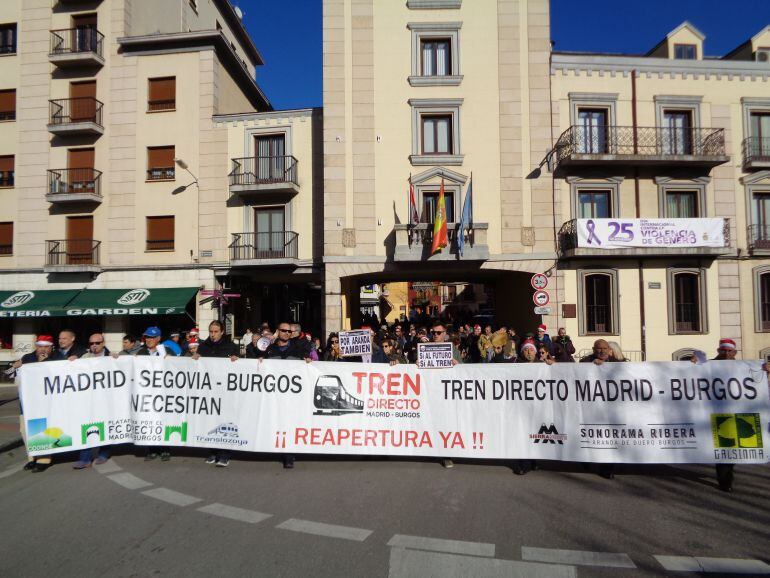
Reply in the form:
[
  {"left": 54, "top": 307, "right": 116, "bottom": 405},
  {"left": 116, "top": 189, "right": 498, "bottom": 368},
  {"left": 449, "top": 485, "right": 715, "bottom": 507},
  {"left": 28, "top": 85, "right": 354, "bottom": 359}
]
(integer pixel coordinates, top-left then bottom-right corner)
[{"left": 0, "top": 447, "right": 770, "bottom": 578}]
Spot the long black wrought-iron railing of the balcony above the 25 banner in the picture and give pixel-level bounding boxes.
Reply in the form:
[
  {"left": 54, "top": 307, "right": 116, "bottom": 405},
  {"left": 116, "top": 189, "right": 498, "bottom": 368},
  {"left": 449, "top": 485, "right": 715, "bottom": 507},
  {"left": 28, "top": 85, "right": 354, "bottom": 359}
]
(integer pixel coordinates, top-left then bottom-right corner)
[{"left": 554, "top": 125, "right": 726, "bottom": 164}]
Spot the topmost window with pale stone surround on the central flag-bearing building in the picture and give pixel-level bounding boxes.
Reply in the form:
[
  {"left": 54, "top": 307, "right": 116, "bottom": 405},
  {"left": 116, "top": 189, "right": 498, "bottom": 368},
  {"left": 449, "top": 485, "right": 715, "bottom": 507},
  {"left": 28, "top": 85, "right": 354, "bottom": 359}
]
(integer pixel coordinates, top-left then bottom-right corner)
[{"left": 407, "top": 22, "right": 462, "bottom": 86}]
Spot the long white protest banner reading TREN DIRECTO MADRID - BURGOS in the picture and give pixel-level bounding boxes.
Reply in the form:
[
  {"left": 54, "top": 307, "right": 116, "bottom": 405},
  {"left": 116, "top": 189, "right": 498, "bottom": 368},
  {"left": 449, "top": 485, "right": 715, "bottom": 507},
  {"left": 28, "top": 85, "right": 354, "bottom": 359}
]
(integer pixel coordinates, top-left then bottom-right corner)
[{"left": 20, "top": 357, "right": 770, "bottom": 463}]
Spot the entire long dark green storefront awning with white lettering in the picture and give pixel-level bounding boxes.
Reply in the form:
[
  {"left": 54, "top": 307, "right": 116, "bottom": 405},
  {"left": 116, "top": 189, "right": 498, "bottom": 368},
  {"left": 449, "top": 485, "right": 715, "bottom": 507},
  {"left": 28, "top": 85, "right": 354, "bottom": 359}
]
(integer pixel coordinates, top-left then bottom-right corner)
[{"left": 0, "top": 287, "right": 198, "bottom": 318}]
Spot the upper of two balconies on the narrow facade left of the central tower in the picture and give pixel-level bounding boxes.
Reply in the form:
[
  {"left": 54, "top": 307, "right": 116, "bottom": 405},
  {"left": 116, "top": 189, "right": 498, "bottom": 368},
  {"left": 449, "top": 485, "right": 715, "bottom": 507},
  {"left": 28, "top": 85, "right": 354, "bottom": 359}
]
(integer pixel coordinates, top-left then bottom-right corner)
[{"left": 230, "top": 155, "right": 299, "bottom": 197}]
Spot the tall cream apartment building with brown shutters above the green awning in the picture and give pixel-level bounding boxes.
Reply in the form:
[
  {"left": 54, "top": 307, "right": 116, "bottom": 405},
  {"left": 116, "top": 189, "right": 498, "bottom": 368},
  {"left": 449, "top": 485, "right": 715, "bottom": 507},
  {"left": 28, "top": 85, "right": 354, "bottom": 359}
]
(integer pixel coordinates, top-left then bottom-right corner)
[{"left": 0, "top": 0, "right": 272, "bottom": 358}]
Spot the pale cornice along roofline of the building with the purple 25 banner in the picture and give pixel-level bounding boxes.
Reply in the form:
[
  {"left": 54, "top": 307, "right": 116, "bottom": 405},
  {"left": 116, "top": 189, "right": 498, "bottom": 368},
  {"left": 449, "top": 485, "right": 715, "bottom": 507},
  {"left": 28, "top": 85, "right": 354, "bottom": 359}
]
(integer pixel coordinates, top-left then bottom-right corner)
[{"left": 551, "top": 52, "right": 770, "bottom": 80}]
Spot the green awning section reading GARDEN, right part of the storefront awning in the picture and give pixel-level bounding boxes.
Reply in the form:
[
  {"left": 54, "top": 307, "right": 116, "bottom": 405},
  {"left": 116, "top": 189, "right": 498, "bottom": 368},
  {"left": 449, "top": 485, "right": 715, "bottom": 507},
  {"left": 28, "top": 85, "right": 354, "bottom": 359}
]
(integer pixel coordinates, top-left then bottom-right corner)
[{"left": 66, "top": 287, "right": 198, "bottom": 317}]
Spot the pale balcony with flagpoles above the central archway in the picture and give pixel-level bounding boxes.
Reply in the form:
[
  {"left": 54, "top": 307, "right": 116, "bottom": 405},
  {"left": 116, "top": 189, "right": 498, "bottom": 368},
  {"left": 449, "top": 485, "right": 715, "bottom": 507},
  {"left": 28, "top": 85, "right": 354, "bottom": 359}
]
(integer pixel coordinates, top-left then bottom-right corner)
[{"left": 393, "top": 223, "right": 489, "bottom": 261}]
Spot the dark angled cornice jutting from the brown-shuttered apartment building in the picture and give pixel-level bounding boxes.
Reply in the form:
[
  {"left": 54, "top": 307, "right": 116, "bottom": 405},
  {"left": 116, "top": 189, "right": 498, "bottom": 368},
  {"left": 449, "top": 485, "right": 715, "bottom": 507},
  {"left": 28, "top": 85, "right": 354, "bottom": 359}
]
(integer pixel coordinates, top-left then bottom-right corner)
[{"left": 118, "top": 30, "right": 273, "bottom": 111}]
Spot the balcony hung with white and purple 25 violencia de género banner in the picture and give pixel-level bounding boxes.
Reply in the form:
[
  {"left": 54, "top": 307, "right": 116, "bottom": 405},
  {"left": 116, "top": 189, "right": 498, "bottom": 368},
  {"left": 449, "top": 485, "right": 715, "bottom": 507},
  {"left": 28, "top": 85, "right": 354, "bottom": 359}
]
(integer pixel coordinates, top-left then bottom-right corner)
[{"left": 558, "top": 217, "right": 733, "bottom": 259}]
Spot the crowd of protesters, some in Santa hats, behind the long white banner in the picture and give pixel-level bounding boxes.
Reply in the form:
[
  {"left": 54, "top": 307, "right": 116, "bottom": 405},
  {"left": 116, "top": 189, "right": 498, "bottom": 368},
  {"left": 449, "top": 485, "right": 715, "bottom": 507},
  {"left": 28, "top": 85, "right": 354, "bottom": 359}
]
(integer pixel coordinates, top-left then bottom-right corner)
[{"left": 12, "top": 317, "right": 752, "bottom": 491}]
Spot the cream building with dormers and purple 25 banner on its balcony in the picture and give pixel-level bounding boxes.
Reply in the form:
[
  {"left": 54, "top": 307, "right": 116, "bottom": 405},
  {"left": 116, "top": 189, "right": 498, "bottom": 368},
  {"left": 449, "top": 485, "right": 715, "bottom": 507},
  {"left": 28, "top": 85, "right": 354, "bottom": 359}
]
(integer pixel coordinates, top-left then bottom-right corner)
[{"left": 550, "top": 22, "right": 770, "bottom": 360}]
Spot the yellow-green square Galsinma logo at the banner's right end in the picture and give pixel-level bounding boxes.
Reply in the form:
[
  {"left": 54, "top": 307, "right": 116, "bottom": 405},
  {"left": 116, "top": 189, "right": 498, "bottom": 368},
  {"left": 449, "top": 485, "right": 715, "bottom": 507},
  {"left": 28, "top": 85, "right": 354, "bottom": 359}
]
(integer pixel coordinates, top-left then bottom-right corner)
[{"left": 711, "top": 413, "right": 764, "bottom": 460}]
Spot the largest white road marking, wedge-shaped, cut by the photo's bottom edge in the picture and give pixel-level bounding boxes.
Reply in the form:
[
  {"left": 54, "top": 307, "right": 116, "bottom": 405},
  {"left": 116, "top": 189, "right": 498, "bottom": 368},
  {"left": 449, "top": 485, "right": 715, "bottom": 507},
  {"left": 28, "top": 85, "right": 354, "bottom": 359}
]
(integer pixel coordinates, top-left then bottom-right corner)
[{"left": 388, "top": 548, "right": 577, "bottom": 578}]
